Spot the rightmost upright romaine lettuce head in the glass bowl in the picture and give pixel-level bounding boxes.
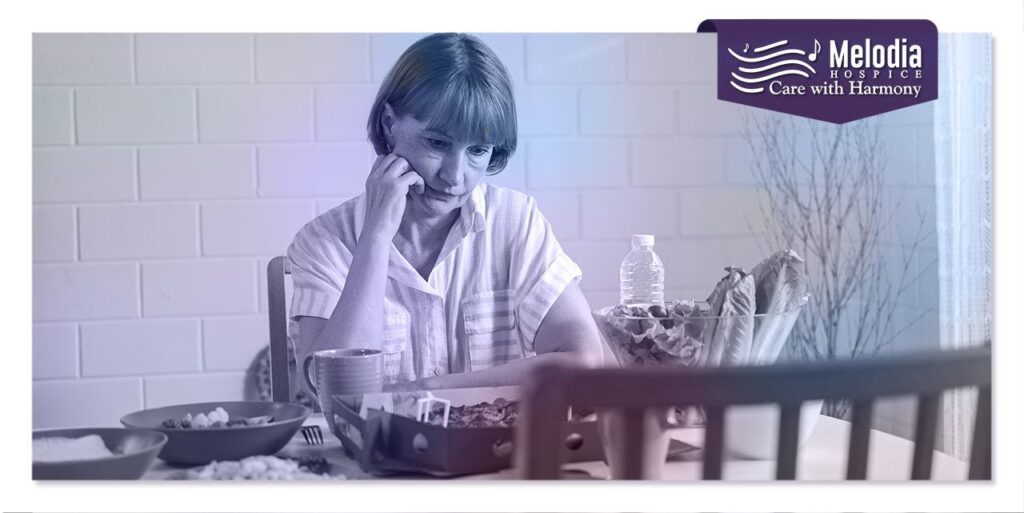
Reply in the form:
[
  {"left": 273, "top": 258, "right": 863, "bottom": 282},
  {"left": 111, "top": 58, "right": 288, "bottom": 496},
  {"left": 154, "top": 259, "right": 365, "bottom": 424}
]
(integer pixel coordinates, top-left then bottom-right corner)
[{"left": 750, "top": 250, "right": 807, "bottom": 364}]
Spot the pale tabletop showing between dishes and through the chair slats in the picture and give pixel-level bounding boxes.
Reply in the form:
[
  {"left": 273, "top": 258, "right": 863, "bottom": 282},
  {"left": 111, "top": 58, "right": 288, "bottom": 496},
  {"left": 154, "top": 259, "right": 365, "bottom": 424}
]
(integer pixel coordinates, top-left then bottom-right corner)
[{"left": 143, "top": 415, "right": 967, "bottom": 481}]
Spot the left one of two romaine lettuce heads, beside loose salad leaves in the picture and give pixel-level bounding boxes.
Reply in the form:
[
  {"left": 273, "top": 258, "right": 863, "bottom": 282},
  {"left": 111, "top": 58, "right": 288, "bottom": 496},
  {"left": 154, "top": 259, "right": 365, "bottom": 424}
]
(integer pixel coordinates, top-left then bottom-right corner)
[{"left": 698, "top": 267, "right": 756, "bottom": 367}]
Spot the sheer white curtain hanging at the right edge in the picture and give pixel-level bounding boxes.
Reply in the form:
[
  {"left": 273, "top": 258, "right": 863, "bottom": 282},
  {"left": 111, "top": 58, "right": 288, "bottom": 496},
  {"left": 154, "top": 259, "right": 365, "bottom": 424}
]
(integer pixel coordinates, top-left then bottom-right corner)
[{"left": 934, "top": 34, "right": 992, "bottom": 460}]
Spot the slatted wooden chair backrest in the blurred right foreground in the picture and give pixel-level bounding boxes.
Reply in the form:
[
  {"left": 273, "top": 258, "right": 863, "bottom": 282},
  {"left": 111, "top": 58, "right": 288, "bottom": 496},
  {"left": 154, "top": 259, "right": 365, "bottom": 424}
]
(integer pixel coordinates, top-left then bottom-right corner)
[{"left": 516, "top": 347, "right": 991, "bottom": 479}]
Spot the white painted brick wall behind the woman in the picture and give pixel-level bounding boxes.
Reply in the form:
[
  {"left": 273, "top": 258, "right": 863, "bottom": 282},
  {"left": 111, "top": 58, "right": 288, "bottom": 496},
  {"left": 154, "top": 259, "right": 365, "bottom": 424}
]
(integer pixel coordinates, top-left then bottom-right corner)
[{"left": 33, "top": 34, "right": 937, "bottom": 427}]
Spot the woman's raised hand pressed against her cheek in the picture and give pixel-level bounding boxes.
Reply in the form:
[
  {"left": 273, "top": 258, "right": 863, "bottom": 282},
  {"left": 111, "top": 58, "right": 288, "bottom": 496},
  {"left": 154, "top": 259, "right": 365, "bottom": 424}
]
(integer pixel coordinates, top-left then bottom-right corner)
[{"left": 359, "top": 153, "right": 425, "bottom": 242}]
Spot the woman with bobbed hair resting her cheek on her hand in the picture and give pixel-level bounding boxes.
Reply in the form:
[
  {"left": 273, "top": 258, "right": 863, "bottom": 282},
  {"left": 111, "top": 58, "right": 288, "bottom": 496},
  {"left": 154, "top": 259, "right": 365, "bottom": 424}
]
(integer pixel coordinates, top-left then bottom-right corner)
[{"left": 288, "top": 34, "right": 601, "bottom": 390}]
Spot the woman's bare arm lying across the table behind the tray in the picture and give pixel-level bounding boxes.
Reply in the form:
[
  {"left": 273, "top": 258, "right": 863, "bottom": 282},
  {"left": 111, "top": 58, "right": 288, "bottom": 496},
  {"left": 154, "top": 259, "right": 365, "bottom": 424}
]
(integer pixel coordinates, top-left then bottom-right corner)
[{"left": 387, "top": 281, "right": 602, "bottom": 390}]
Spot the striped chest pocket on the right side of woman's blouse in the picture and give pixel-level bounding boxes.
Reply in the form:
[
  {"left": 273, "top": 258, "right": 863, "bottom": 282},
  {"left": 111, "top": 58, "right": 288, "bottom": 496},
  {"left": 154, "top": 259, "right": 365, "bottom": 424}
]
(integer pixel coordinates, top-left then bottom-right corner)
[{"left": 462, "top": 289, "right": 524, "bottom": 371}]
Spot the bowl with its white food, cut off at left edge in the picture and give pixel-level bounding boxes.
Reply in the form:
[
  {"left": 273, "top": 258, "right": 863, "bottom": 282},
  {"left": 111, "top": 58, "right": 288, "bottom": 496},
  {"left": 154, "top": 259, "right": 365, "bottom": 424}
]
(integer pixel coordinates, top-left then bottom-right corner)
[{"left": 32, "top": 428, "right": 167, "bottom": 479}]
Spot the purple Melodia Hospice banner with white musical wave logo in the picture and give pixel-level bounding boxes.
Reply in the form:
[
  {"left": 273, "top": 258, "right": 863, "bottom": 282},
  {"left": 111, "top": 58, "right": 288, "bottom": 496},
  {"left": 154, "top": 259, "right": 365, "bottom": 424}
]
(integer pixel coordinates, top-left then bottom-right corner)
[{"left": 697, "top": 19, "right": 938, "bottom": 123}]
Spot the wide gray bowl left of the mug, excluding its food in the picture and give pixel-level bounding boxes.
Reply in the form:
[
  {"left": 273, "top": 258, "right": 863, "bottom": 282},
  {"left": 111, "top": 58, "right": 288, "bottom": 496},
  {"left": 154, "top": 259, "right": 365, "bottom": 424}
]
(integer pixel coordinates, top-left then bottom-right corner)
[{"left": 121, "top": 401, "right": 310, "bottom": 466}]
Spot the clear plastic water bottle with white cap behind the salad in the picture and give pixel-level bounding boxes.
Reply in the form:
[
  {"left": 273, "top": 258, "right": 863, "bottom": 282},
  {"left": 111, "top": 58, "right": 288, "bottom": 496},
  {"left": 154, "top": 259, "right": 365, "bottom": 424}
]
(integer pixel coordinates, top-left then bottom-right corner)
[{"left": 618, "top": 236, "right": 665, "bottom": 306}]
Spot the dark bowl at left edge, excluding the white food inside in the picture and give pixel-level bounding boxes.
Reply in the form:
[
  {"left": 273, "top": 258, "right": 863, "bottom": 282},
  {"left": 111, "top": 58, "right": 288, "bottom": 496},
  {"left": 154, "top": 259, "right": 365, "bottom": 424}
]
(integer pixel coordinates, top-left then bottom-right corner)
[{"left": 32, "top": 428, "right": 167, "bottom": 479}]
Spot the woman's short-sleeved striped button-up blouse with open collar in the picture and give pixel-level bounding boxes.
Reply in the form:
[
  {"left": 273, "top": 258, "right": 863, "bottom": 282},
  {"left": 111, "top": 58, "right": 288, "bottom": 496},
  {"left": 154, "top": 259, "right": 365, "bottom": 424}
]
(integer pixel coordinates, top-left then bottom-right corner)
[{"left": 288, "top": 182, "right": 583, "bottom": 383}]
